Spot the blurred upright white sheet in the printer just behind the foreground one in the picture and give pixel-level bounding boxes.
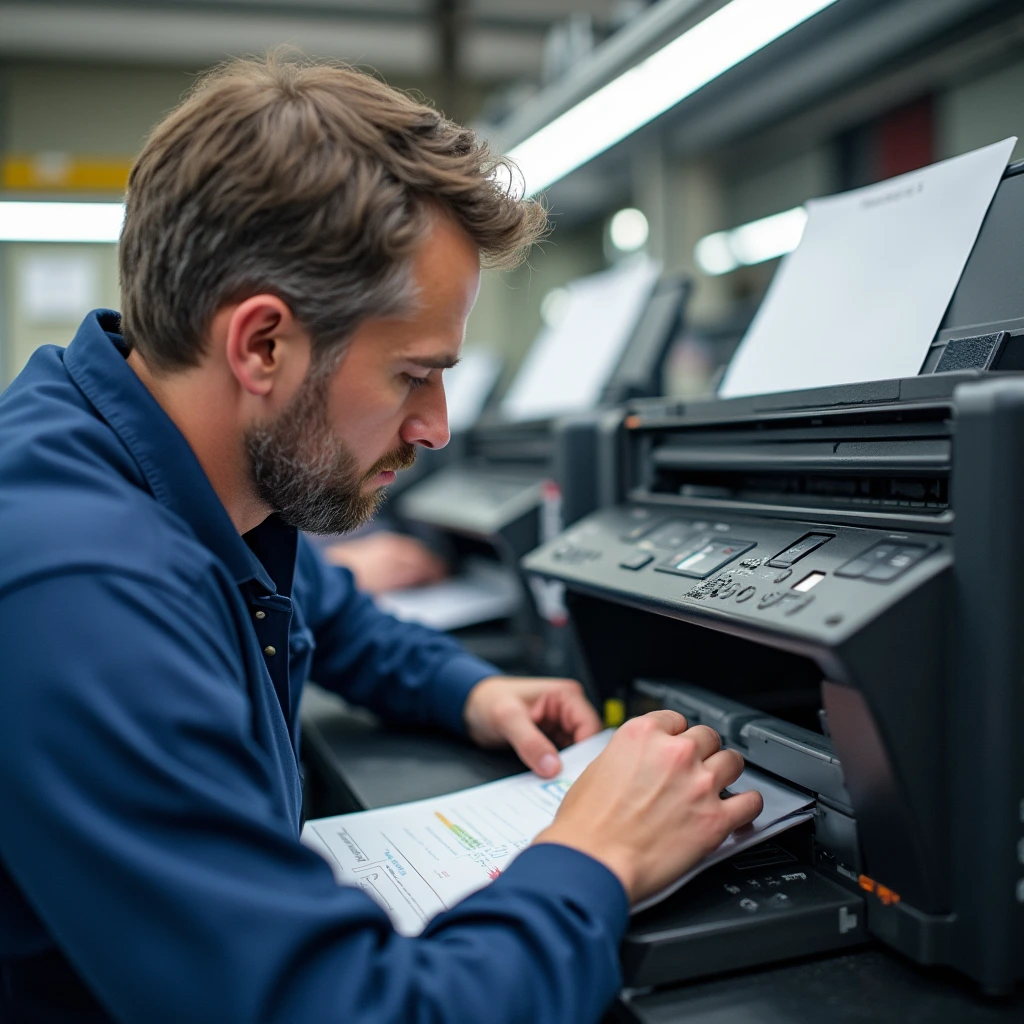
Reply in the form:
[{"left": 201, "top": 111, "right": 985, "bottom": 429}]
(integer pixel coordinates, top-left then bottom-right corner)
[{"left": 501, "top": 258, "right": 659, "bottom": 422}]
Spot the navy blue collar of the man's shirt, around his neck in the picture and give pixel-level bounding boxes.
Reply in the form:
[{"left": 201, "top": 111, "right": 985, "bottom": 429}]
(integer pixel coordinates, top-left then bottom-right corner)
[{"left": 63, "top": 309, "right": 297, "bottom": 594}]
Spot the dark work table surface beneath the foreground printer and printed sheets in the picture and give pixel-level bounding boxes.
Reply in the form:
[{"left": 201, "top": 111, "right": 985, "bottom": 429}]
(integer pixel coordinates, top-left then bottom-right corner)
[{"left": 302, "top": 686, "right": 1024, "bottom": 1024}]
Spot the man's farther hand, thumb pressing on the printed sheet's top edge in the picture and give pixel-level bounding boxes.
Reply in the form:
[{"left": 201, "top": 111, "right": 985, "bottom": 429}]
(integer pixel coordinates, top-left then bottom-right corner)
[{"left": 463, "top": 676, "right": 601, "bottom": 778}]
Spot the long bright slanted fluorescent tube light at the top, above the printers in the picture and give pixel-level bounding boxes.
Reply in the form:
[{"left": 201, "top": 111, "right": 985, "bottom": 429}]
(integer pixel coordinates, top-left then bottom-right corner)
[{"left": 509, "top": 0, "right": 836, "bottom": 196}]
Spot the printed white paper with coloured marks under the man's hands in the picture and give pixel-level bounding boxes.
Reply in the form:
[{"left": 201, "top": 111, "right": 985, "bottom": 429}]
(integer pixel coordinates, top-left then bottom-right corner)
[{"left": 302, "top": 729, "right": 812, "bottom": 935}]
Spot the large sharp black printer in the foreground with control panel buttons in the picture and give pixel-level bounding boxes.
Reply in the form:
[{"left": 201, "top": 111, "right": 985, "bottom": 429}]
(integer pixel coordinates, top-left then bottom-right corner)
[{"left": 523, "top": 157, "right": 1024, "bottom": 993}]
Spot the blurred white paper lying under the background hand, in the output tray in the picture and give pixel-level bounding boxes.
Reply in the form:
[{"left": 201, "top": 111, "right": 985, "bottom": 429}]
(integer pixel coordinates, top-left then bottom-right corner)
[{"left": 376, "top": 559, "right": 522, "bottom": 632}]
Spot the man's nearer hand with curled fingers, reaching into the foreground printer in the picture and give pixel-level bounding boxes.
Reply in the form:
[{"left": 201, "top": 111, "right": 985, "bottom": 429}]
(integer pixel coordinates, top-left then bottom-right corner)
[{"left": 536, "top": 711, "right": 763, "bottom": 903}]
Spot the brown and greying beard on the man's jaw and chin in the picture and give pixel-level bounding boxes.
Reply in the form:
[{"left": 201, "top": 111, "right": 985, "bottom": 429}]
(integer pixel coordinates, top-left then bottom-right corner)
[{"left": 245, "top": 374, "right": 416, "bottom": 534}]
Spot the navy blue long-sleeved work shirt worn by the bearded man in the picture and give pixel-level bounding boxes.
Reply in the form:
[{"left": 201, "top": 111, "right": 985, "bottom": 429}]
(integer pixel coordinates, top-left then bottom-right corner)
[{"left": 0, "top": 312, "right": 628, "bottom": 1024}]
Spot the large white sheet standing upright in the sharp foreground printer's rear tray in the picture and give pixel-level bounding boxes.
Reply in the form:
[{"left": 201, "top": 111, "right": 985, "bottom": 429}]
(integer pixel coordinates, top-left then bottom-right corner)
[{"left": 719, "top": 138, "right": 1017, "bottom": 398}]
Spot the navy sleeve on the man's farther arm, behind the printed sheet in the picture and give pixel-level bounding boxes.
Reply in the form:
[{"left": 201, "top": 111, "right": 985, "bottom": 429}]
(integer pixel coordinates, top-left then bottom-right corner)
[{"left": 293, "top": 536, "right": 502, "bottom": 732}]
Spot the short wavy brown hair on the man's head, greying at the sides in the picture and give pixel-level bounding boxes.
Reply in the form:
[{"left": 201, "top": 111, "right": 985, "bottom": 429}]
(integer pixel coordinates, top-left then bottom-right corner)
[{"left": 119, "top": 53, "right": 547, "bottom": 371}]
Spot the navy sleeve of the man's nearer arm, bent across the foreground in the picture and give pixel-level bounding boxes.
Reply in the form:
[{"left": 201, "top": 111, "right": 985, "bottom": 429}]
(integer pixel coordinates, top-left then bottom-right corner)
[{"left": 0, "top": 574, "right": 627, "bottom": 1024}]
